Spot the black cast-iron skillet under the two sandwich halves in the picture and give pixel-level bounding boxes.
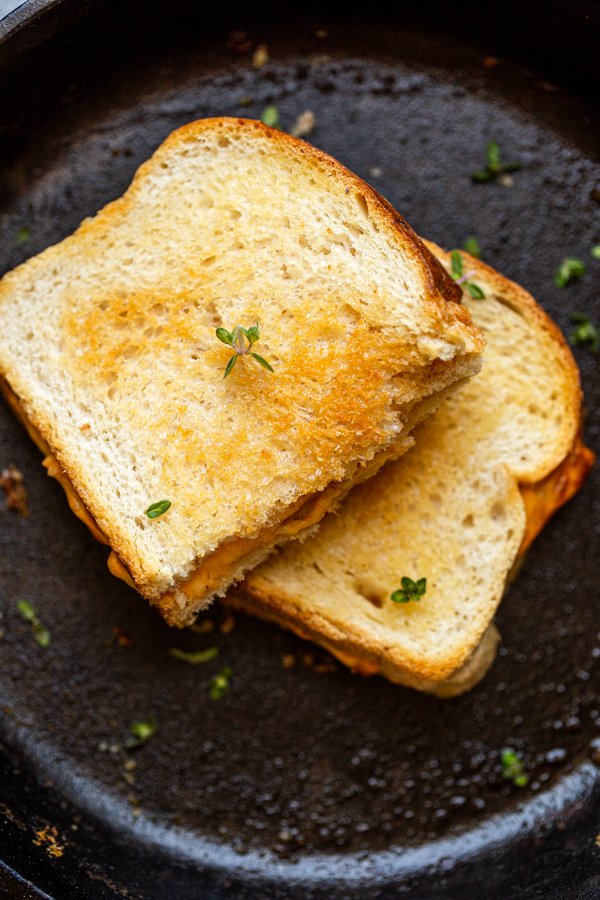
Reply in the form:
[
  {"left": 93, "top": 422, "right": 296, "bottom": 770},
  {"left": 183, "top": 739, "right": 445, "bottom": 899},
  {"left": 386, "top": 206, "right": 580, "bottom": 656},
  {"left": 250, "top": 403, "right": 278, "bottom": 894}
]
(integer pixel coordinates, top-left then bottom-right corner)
[{"left": 0, "top": 0, "right": 600, "bottom": 900}]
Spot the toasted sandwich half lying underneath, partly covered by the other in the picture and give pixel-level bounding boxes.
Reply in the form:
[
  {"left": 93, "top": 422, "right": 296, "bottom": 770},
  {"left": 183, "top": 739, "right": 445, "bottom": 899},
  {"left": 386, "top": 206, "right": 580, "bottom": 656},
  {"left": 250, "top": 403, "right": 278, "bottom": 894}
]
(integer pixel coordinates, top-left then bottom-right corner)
[{"left": 230, "top": 245, "right": 593, "bottom": 696}]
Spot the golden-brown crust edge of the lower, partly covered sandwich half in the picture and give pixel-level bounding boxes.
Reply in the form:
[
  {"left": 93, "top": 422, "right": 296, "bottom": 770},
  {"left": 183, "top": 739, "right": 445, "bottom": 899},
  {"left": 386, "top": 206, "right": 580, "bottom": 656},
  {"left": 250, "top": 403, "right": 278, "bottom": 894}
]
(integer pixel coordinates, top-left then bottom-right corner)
[{"left": 236, "top": 243, "right": 594, "bottom": 696}]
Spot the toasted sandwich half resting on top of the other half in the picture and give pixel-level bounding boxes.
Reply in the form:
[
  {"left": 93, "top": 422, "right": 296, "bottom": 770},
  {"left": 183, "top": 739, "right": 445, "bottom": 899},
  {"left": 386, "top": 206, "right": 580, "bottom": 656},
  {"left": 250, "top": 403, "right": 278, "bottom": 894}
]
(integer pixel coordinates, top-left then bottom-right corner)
[{"left": 0, "top": 119, "right": 483, "bottom": 625}]
